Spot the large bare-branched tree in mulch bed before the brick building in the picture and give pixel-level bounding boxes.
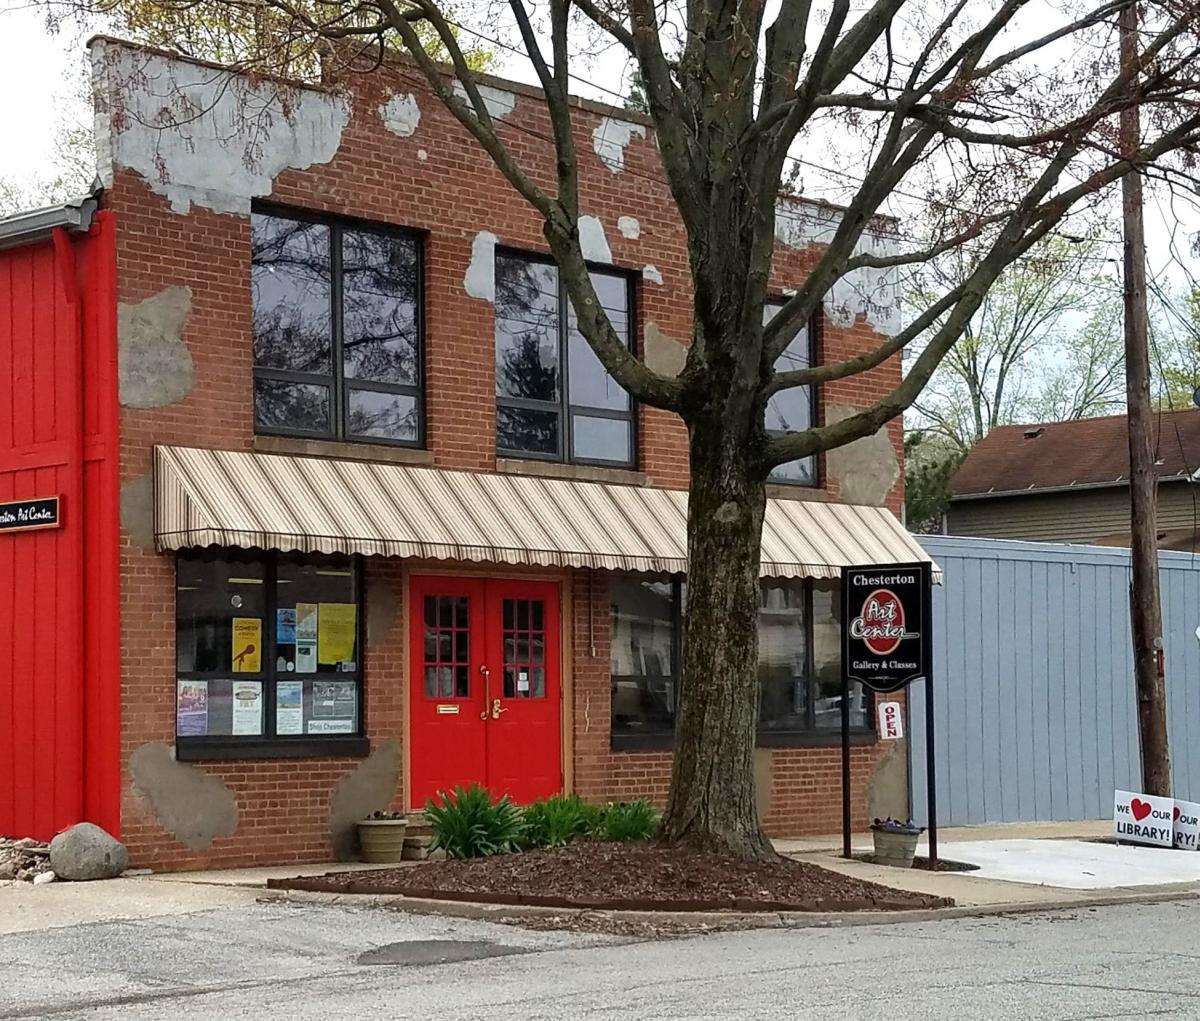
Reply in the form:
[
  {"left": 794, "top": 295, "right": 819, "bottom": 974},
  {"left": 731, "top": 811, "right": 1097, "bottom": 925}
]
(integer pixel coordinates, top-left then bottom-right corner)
[{"left": 44, "top": 0, "right": 1200, "bottom": 858}]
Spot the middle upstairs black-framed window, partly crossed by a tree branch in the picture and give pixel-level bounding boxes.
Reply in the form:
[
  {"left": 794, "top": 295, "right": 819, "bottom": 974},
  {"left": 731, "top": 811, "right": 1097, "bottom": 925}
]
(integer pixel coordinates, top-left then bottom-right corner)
[{"left": 496, "top": 252, "right": 634, "bottom": 466}]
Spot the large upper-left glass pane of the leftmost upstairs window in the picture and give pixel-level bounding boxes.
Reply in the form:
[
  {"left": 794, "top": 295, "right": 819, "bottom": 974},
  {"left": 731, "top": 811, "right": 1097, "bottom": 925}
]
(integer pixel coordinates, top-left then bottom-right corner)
[{"left": 251, "top": 214, "right": 332, "bottom": 373}]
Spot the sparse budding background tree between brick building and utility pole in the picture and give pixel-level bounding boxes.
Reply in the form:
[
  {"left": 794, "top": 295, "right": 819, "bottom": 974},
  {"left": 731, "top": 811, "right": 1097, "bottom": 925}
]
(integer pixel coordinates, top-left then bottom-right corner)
[{"left": 910, "top": 236, "right": 1124, "bottom": 452}]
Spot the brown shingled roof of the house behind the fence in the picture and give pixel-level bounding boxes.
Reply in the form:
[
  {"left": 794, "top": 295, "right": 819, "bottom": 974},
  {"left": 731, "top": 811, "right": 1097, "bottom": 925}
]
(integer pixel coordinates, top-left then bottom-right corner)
[{"left": 950, "top": 409, "right": 1200, "bottom": 499}]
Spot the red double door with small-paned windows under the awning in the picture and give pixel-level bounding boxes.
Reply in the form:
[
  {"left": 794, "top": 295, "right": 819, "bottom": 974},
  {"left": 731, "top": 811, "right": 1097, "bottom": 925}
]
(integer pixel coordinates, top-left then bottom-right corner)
[{"left": 409, "top": 576, "right": 563, "bottom": 809}]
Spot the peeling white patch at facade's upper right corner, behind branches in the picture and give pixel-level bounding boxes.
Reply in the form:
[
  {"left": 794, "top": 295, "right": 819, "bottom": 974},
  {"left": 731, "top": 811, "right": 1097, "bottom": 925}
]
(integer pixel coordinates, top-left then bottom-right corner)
[{"left": 775, "top": 199, "right": 900, "bottom": 336}]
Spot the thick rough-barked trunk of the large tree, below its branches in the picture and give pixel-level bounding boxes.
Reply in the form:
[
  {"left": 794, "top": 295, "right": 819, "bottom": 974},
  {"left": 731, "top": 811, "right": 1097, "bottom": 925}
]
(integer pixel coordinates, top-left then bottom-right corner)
[{"left": 662, "top": 415, "right": 774, "bottom": 859}]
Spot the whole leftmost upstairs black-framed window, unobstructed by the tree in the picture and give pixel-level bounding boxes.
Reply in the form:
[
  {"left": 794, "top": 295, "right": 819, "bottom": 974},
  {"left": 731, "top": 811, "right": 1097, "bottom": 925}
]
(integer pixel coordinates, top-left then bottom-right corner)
[{"left": 251, "top": 211, "right": 424, "bottom": 446}]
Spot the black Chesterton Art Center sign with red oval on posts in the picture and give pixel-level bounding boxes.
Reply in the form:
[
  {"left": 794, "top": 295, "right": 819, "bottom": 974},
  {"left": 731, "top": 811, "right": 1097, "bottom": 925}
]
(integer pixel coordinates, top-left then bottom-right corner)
[{"left": 841, "top": 561, "right": 932, "bottom": 692}]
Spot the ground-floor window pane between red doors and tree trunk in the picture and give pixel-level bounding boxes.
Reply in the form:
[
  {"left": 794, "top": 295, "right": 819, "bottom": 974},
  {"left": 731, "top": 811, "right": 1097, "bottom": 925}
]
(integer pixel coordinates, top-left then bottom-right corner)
[{"left": 611, "top": 577, "right": 676, "bottom": 734}]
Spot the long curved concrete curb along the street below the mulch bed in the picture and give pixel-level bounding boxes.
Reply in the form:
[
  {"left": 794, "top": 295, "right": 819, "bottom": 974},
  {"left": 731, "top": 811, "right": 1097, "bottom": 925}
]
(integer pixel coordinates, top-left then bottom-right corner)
[{"left": 258, "top": 884, "right": 1200, "bottom": 931}]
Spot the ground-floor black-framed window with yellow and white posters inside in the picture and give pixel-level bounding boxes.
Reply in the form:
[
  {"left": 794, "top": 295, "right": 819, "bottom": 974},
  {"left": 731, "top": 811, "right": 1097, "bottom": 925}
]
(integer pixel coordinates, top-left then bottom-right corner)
[{"left": 175, "top": 549, "right": 362, "bottom": 758}]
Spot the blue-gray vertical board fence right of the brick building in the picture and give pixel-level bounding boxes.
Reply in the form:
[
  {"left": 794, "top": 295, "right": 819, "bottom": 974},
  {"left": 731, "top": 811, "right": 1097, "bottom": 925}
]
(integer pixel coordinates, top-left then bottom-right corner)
[{"left": 908, "top": 536, "right": 1200, "bottom": 825}]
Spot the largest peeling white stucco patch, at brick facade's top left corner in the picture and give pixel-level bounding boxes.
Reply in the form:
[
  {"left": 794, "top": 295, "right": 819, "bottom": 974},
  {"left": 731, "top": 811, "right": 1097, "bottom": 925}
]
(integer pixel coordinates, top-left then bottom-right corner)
[{"left": 91, "top": 41, "right": 350, "bottom": 214}]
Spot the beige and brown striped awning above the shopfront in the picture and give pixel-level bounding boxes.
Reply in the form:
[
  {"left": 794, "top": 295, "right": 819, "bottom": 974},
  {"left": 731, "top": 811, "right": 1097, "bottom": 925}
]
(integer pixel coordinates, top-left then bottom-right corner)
[{"left": 155, "top": 446, "right": 929, "bottom": 578}]
